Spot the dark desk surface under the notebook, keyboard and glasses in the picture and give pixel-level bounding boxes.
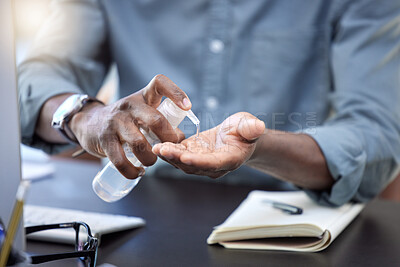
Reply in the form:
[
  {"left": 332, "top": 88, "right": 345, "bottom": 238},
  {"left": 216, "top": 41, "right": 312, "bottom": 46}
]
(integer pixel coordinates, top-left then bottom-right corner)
[{"left": 27, "top": 161, "right": 400, "bottom": 267}]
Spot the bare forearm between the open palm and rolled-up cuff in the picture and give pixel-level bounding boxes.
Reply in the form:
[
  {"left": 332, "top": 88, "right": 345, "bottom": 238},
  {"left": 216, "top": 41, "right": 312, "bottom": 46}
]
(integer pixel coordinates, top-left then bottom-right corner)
[{"left": 247, "top": 130, "right": 334, "bottom": 190}]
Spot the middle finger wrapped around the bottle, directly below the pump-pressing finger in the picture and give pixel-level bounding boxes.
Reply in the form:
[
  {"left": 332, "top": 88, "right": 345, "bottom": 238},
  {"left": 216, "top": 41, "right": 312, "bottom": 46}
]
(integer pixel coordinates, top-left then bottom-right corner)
[{"left": 131, "top": 104, "right": 180, "bottom": 143}]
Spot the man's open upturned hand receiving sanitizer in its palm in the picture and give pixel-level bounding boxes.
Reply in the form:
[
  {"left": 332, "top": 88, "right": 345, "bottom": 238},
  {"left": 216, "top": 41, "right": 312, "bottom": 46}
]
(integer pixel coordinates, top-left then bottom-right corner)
[{"left": 153, "top": 112, "right": 265, "bottom": 178}]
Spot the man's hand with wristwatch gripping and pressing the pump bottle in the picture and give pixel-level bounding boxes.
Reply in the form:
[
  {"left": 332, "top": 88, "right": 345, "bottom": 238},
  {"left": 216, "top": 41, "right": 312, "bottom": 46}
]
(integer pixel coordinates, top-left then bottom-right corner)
[{"left": 69, "top": 75, "right": 191, "bottom": 179}]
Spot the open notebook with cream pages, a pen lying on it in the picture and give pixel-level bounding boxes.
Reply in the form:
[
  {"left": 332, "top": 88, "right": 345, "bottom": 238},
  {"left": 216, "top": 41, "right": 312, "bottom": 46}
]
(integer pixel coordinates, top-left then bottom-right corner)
[{"left": 207, "top": 191, "right": 364, "bottom": 252}]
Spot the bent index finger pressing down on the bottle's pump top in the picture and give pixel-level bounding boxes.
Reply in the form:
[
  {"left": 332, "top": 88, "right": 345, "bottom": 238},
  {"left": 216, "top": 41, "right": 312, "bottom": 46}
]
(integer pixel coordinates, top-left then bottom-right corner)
[{"left": 143, "top": 74, "right": 192, "bottom": 110}]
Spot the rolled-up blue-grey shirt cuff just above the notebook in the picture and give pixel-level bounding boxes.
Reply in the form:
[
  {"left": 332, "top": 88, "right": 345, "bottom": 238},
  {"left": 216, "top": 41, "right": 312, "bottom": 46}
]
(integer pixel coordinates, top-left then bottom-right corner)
[{"left": 301, "top": 125, "right": 367, "bottom": 206}]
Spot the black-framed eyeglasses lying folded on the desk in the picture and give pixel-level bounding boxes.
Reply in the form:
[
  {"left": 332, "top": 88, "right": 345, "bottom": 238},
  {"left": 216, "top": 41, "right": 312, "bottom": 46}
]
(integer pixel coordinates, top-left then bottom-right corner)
[{"left": 0, "top": 222, "right": 99, "bottom": 267}]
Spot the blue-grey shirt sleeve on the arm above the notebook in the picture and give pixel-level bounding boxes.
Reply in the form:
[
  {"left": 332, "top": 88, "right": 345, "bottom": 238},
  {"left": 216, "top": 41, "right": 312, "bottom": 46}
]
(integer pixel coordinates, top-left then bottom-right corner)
[{"left": 305, "top": 0, "right": 400, "bottom": 206}]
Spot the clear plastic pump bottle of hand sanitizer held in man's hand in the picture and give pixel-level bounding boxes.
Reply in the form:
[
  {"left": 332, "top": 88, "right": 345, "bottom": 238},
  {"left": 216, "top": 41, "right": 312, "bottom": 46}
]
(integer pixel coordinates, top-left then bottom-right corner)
[{"left": 92, "top": 98, "right": 200, "bottom": 202}]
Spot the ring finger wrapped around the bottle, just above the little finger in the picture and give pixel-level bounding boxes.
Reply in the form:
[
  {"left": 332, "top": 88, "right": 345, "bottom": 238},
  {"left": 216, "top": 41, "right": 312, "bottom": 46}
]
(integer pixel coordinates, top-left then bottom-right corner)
[{"left": 118, "top": 123, "right": 157, "bottom": 166}]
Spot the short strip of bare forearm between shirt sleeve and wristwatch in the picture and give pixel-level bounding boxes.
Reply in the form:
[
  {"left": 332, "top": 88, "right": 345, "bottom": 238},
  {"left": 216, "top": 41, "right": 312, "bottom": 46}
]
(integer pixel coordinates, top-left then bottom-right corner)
[{"left": 35, "top": 93, "right": 72, "bottom": 144}]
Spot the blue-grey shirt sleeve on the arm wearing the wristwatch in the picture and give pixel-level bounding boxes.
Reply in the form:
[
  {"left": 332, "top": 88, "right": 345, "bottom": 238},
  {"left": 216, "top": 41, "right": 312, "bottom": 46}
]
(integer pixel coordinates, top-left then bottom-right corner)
[{"left": 18, "top": 0, "right": 110, "bottom": 153}]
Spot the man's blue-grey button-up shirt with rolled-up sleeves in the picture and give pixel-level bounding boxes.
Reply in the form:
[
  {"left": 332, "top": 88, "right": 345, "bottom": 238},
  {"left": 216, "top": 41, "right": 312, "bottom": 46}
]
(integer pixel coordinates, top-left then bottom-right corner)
[{"left": 19, "top": 0, "right": 400, "bottom": 205}]
